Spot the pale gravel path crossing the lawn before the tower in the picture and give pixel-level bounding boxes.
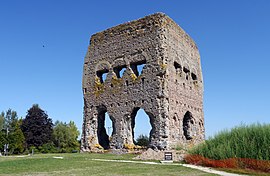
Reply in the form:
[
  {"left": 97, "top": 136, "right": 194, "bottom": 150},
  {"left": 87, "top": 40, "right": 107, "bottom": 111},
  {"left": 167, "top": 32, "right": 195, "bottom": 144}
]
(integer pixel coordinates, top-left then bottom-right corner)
[{"left": 92, "top": 159, "right": 244, "bottom": 176}]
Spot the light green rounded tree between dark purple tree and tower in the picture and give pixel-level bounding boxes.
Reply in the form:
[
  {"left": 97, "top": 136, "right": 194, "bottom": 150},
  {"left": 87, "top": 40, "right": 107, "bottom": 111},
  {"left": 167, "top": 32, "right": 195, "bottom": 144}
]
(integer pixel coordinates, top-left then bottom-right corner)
[{"left": 53, "top": 121, "right": 80, "bottom": 152}]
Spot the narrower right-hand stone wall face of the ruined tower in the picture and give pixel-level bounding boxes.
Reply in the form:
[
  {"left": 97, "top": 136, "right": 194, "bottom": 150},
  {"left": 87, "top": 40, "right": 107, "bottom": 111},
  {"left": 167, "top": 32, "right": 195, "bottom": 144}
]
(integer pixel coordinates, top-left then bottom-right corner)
[{"left": 161, "top": 18, "right": 205, "bottom": 147}]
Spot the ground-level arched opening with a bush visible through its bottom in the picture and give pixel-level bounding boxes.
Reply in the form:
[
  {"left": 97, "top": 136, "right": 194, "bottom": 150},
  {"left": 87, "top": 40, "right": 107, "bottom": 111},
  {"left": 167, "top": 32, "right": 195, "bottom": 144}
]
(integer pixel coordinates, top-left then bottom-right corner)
[{"left": 131, "top": 107, "right": 155, "bottom": 147}]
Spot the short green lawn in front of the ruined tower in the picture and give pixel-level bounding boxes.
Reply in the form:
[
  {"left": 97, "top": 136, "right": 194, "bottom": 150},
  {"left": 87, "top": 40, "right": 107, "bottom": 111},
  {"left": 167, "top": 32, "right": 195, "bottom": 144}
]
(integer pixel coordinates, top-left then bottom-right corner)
[{"left": 0, "top": 153, "right": 217, "bottom": 176}]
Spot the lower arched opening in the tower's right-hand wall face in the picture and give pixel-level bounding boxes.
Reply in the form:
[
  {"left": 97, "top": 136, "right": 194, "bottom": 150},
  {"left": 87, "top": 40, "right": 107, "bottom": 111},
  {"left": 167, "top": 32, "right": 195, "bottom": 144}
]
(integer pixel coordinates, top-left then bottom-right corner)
[{"left": 183, "top": 111, "right": 194, "bottom": 140}]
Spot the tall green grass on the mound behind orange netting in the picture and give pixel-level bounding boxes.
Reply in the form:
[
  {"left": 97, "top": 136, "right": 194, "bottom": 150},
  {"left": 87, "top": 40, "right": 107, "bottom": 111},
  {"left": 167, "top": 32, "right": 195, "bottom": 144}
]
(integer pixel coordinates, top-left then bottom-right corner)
[{"left": 189, "top": 123, "right": 270, "bottom": 160}]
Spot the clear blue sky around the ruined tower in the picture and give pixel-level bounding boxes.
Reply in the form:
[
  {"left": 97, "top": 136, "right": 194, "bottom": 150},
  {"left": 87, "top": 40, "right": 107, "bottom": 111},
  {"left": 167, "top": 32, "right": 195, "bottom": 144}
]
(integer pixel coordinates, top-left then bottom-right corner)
[{"left": 0, "top": 0, "right": 270, "bottom": 139}]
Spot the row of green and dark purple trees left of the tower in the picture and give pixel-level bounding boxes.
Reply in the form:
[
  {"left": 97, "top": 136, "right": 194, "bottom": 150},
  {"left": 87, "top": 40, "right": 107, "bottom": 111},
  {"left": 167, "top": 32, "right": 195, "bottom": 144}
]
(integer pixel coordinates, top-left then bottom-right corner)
[{"left": 0, "top": 104, "right": 80, "bottom": 155}]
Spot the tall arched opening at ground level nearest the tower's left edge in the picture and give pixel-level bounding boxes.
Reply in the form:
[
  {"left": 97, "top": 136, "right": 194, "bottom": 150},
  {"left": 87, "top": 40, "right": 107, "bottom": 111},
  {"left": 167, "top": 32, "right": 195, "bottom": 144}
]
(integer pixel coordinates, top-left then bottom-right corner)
[{"left": 97, "top": 106, "right": 114, "bottom": 149}]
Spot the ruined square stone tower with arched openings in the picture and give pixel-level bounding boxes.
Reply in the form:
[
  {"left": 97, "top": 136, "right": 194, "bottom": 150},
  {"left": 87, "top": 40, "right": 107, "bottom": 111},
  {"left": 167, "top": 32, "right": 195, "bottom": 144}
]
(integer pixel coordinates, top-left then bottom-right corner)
[{"left": 81, "top": 13, "right": 204, "bottom": 151}]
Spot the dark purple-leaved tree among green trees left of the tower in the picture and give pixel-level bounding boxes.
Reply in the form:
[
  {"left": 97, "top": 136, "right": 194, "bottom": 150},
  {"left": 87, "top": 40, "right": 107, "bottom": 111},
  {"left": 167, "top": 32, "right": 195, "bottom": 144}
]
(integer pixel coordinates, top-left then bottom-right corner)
[{"left": 21, "top": 104, "right": 53, "bottom": 148}]
